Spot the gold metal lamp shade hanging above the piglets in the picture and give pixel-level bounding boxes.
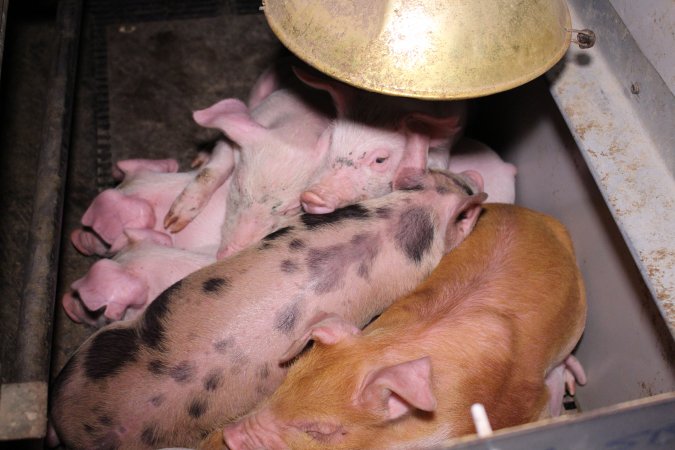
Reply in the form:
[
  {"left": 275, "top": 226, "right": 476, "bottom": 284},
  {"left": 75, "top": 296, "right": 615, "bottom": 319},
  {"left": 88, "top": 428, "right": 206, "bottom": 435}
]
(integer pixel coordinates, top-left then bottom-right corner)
[{"left": 264, "top": 0, "right": 571, "bottom": 99}]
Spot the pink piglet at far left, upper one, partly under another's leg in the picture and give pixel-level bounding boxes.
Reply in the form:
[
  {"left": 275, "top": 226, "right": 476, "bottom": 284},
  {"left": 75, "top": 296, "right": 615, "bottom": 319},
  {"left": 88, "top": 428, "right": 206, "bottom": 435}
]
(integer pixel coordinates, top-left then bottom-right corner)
[{"left": 71, "top": 148, "right": 230, "bottom": 256}]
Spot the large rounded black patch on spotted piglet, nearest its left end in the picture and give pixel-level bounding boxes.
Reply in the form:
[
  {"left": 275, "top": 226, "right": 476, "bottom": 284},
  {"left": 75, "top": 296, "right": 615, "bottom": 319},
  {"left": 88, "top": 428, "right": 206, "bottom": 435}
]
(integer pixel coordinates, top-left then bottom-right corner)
[{"left": 84, "top": 328, "right": 139, "bottom": 380}]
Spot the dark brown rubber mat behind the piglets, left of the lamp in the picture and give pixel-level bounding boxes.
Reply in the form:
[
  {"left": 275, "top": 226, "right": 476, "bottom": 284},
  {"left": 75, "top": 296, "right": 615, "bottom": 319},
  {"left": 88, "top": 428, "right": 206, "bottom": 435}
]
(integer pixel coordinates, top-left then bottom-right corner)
[{"left": 90, "top": 0, "right": 280, "bottom": 189}]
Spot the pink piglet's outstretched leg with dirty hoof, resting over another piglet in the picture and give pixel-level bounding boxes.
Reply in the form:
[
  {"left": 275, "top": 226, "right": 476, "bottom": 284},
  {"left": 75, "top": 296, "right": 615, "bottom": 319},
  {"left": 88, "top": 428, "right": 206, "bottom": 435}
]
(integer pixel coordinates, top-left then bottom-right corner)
[{"left": 164, "top": 141, "right": 234, "bottom": 233}]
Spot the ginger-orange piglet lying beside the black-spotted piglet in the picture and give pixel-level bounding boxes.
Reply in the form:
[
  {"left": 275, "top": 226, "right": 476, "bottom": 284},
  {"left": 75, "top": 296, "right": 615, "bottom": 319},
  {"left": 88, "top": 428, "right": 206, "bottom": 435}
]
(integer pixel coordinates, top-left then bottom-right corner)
[{"left": 220, "top": 204, "right": 586, "bottom": 450}]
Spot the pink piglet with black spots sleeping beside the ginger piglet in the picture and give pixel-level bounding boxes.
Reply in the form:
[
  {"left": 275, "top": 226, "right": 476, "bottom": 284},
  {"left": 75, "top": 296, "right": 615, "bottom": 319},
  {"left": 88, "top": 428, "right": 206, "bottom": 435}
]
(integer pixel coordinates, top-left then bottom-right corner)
[{"left": 50, "top": 167, "right": 486, "bottom": 449}]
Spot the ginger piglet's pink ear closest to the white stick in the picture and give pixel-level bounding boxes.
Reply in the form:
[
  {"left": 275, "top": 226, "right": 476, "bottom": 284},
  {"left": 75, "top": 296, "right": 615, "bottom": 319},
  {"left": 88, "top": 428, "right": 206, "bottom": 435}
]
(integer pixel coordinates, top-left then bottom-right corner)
[{"left": 357, "top": 356, "right": 436, "bottom": 420}]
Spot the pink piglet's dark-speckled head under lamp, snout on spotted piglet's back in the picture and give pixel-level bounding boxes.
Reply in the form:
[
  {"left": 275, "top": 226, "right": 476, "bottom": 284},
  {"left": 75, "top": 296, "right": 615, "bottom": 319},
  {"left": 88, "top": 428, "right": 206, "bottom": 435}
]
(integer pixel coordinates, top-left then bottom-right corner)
[{"left": 296, "top": 70, "right": 466, "bottom": 214}]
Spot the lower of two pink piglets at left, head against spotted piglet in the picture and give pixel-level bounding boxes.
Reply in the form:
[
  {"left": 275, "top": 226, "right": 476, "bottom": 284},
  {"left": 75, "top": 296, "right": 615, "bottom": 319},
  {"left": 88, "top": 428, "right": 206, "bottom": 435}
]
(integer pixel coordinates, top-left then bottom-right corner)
[{"left": 62, "top": 229, "right": 217, "bottom": 327}]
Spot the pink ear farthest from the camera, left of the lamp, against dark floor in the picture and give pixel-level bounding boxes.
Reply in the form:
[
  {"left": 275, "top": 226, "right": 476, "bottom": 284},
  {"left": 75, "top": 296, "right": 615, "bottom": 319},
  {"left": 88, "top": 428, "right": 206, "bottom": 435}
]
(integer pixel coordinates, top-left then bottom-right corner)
[{"left": 192, "top": 98, "right": 266, "bottom": 145}]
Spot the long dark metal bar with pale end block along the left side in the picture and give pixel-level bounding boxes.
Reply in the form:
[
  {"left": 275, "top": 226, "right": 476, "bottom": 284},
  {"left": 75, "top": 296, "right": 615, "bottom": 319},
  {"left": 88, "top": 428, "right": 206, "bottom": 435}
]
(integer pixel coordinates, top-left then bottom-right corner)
[{"left": 0, "top": 0, "right": 82, "bottom": 439}]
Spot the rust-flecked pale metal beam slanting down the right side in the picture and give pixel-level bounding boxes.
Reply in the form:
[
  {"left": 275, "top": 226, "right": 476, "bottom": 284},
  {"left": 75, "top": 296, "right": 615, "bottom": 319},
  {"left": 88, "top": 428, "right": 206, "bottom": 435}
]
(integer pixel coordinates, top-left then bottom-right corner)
[{"left": 550, "top": 0, "right": 675, "bottom": 336}]
